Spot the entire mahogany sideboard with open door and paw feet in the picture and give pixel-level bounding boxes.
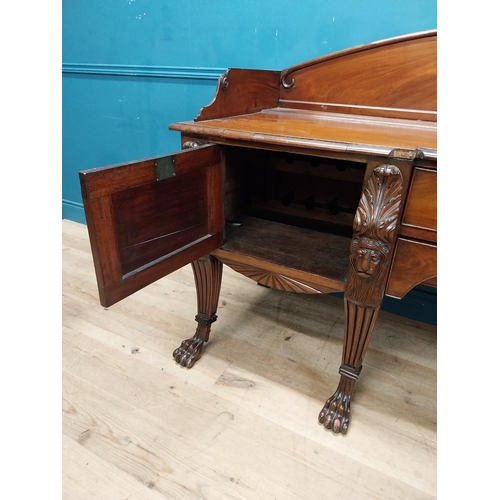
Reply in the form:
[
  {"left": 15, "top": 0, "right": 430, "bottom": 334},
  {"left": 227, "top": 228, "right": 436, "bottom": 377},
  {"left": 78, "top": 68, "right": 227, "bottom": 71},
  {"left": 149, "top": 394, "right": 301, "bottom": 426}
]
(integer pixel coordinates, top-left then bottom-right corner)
[{"left": 79, "top": 31, "right": 437, "bottom": 434}]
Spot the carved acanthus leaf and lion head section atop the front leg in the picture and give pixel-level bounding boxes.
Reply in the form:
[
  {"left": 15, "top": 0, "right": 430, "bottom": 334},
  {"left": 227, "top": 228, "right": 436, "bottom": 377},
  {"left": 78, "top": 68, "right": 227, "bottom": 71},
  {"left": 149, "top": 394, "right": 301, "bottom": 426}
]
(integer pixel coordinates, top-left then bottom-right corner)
[{"left": 346, "top": 165, "right": 403, "bottom": 304}]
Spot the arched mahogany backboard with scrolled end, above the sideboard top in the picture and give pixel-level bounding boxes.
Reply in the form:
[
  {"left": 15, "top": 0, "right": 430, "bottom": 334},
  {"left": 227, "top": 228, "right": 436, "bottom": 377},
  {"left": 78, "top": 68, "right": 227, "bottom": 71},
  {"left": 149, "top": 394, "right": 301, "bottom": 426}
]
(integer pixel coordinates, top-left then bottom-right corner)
[{"left": 280, "top": 31, "right": 437, "bottom": 121}]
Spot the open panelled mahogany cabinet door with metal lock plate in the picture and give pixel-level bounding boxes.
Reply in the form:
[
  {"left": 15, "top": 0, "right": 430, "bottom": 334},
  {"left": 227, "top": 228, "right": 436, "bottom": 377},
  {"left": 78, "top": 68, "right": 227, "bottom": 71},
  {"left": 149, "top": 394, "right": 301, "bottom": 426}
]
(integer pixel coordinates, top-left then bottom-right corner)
[{"left": 79, "top": 145, "right": 223, "bottom": 307}]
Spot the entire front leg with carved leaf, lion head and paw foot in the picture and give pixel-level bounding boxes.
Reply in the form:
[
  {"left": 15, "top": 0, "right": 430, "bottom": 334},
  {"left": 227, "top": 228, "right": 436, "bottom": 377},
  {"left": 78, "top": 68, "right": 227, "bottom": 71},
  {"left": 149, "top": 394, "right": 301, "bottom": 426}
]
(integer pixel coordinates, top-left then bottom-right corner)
[{"left": 318, "top": 165, "right": 403, "bottom": 434}]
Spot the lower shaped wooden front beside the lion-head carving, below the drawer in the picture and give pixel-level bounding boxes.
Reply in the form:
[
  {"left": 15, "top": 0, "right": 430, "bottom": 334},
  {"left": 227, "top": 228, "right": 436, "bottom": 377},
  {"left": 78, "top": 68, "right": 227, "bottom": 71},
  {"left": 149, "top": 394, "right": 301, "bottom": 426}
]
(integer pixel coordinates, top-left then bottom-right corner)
[{"left": 386, "top": 238, "right": 437, "bottom": 299}]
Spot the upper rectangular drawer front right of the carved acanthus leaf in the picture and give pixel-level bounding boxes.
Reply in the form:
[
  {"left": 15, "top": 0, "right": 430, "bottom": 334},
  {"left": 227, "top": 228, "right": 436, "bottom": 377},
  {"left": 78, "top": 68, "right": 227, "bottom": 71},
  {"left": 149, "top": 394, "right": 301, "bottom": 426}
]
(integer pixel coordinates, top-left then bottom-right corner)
[{"left": 402, "top": 167, "right": 437, "bottom": 231}]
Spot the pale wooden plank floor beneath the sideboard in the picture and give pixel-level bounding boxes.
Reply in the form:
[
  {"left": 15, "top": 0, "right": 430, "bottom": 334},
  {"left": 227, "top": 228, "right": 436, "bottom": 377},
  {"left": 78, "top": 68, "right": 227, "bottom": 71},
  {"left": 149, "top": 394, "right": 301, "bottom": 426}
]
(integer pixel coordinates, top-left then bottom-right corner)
[{"left": 62, "top": 221, "right": 436, "bottom": 500}]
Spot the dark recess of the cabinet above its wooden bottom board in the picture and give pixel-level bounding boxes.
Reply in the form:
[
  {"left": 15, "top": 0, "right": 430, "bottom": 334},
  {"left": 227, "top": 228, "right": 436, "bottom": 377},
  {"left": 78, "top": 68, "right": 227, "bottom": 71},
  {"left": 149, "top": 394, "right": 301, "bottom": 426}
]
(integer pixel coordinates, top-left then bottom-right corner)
[{"left": 224, "top": 147, "right": 366, "bottom": 238}]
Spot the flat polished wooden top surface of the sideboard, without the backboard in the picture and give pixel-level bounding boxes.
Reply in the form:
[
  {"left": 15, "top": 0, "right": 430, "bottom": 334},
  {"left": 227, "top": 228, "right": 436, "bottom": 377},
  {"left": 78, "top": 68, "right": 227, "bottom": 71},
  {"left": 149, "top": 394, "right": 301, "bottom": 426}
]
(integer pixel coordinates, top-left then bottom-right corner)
[{"left": 171, "top": 108, "right": 437, "bottom": 159}]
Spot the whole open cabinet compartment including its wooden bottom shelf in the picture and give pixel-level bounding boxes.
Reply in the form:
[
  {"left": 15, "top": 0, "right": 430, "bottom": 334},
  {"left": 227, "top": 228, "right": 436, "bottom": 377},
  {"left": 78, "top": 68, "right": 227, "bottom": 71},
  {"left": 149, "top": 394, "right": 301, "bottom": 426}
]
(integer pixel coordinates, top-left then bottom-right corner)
[{"left": 217, "top": 147, "right": 366, "bottom": 282}]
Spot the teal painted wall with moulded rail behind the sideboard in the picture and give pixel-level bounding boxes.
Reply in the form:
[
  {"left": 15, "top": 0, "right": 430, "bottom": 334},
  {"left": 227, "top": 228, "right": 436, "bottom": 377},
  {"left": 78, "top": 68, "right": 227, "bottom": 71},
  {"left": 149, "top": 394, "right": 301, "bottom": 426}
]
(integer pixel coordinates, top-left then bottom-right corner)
[{"left": 62, "top": 0, "right": 437, "bottom": 324}]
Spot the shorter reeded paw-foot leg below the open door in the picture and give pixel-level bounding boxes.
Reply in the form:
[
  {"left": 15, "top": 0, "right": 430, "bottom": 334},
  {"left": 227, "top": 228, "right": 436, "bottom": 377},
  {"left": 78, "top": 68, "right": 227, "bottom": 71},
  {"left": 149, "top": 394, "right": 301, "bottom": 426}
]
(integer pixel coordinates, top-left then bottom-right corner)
[{"left": 173, "top": 255, "right": 222, "bottom": 368}]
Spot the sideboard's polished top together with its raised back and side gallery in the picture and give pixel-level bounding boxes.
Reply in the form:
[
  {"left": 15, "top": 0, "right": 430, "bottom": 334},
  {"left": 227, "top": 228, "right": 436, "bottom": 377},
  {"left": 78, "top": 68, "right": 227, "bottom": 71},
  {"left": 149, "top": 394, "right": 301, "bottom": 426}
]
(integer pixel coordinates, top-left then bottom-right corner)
[{"left": 170, "top": 31, "right": 437, "bottom": 161}]
